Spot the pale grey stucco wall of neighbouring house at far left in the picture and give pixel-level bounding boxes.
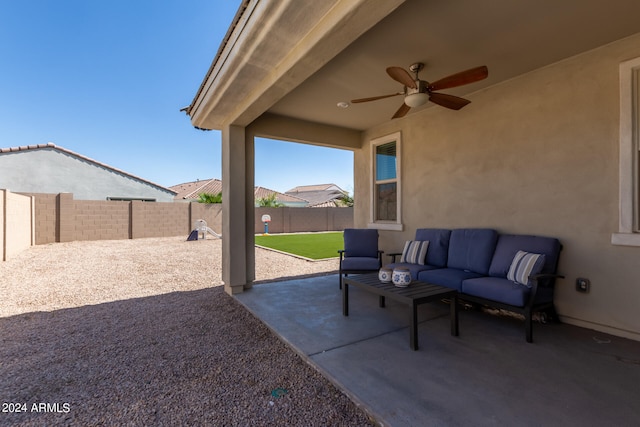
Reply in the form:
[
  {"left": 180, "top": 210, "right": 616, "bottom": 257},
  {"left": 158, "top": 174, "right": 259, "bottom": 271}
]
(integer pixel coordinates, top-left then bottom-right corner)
[{"left": 0, "top": 147, "right": 174, "bottom": 202}]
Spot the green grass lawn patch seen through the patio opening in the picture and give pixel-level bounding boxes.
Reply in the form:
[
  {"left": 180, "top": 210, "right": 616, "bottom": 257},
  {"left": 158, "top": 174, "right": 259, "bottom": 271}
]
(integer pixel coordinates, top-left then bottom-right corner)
[{"left": 256, "top": 232, "right": 344, "bottom": 259}]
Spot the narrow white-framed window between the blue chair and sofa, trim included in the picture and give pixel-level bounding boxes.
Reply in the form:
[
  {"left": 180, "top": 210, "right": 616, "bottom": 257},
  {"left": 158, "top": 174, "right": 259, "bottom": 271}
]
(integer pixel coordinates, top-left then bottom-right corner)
[{"left": 369, "top": 132, "right": 402, "bottom": 230}]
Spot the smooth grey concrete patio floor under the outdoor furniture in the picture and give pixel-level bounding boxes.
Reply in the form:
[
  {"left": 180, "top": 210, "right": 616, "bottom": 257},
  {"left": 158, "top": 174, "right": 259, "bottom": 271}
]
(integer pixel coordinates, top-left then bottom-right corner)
[{"left": 236, "top": 275, "right": 640, "bottom": 426}]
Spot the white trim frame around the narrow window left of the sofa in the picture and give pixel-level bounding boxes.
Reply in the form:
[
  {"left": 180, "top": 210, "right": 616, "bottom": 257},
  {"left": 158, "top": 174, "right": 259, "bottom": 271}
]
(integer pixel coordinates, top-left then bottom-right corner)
[{"left": 367, "top": 132, "right": 404, "bottom": 231}]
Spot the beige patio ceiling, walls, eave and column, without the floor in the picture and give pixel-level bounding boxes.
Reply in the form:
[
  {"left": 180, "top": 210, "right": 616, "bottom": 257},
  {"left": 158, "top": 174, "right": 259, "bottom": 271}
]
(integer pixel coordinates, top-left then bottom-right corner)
[{"left": 184, "top": 0, "right": 640, "bottom": 341}]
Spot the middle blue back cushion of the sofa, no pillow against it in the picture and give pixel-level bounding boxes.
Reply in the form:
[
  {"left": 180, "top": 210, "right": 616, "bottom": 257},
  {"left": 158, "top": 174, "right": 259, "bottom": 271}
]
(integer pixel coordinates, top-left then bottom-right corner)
[{"left": 447, "top": 228, "right": 498, "bottom": 274}]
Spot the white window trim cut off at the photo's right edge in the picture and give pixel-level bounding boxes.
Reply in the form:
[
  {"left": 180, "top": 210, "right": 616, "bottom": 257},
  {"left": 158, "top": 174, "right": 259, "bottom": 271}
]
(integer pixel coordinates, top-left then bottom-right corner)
[{"left": 611, "top": 58, "right": 640, "bottom": 246}]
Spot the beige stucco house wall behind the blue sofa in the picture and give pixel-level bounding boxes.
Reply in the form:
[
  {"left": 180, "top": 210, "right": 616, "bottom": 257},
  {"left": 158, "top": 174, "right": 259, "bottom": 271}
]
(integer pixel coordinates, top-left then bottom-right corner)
[{"left": 354, "top": 34, "right": 640, "bottom": 339}]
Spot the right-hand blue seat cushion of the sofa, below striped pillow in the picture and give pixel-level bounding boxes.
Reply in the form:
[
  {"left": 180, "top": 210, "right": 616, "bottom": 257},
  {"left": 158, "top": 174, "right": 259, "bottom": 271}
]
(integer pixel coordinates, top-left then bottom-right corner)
[{"left": 460, "top": 277, "right": 531, "bottom": 307}]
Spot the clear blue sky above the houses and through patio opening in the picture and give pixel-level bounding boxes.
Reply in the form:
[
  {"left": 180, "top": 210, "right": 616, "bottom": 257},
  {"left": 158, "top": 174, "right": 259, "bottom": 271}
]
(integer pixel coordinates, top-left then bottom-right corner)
[{"left": 0, "top": 0, "right": 353, "bottom": 192}]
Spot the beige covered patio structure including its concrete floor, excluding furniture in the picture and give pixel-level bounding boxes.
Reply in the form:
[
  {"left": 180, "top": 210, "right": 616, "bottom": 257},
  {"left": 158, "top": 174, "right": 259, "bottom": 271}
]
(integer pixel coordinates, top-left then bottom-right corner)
[{"left": 179, "top": 0, "right": 640, "bottom": 426}]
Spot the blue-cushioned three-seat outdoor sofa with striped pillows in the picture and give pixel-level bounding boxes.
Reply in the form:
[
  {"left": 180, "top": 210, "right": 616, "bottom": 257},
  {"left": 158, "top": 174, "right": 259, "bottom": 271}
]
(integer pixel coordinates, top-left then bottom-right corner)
[{"left": 386, "top": 228, "right": 563, "bottom": 342}]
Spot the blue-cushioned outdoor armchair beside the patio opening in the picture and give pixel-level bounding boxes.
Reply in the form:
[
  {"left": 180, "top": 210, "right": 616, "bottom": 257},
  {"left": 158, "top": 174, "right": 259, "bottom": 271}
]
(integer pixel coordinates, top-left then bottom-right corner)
[{"left": 338, "top": 228, "right": 383, "bottom": 289}]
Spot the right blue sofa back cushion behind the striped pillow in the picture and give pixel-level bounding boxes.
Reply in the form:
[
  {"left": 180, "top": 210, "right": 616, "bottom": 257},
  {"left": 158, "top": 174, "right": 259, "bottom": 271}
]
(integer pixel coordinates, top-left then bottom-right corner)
[{"left": 489, "top": 234, "right": 562, "bottom": 277}]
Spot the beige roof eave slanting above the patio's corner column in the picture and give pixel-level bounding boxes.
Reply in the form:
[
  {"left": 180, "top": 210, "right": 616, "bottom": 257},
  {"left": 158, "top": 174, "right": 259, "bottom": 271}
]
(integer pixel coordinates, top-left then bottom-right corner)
[{"left": 187, "top": 0, "right": 405, "bottom": 130}]
